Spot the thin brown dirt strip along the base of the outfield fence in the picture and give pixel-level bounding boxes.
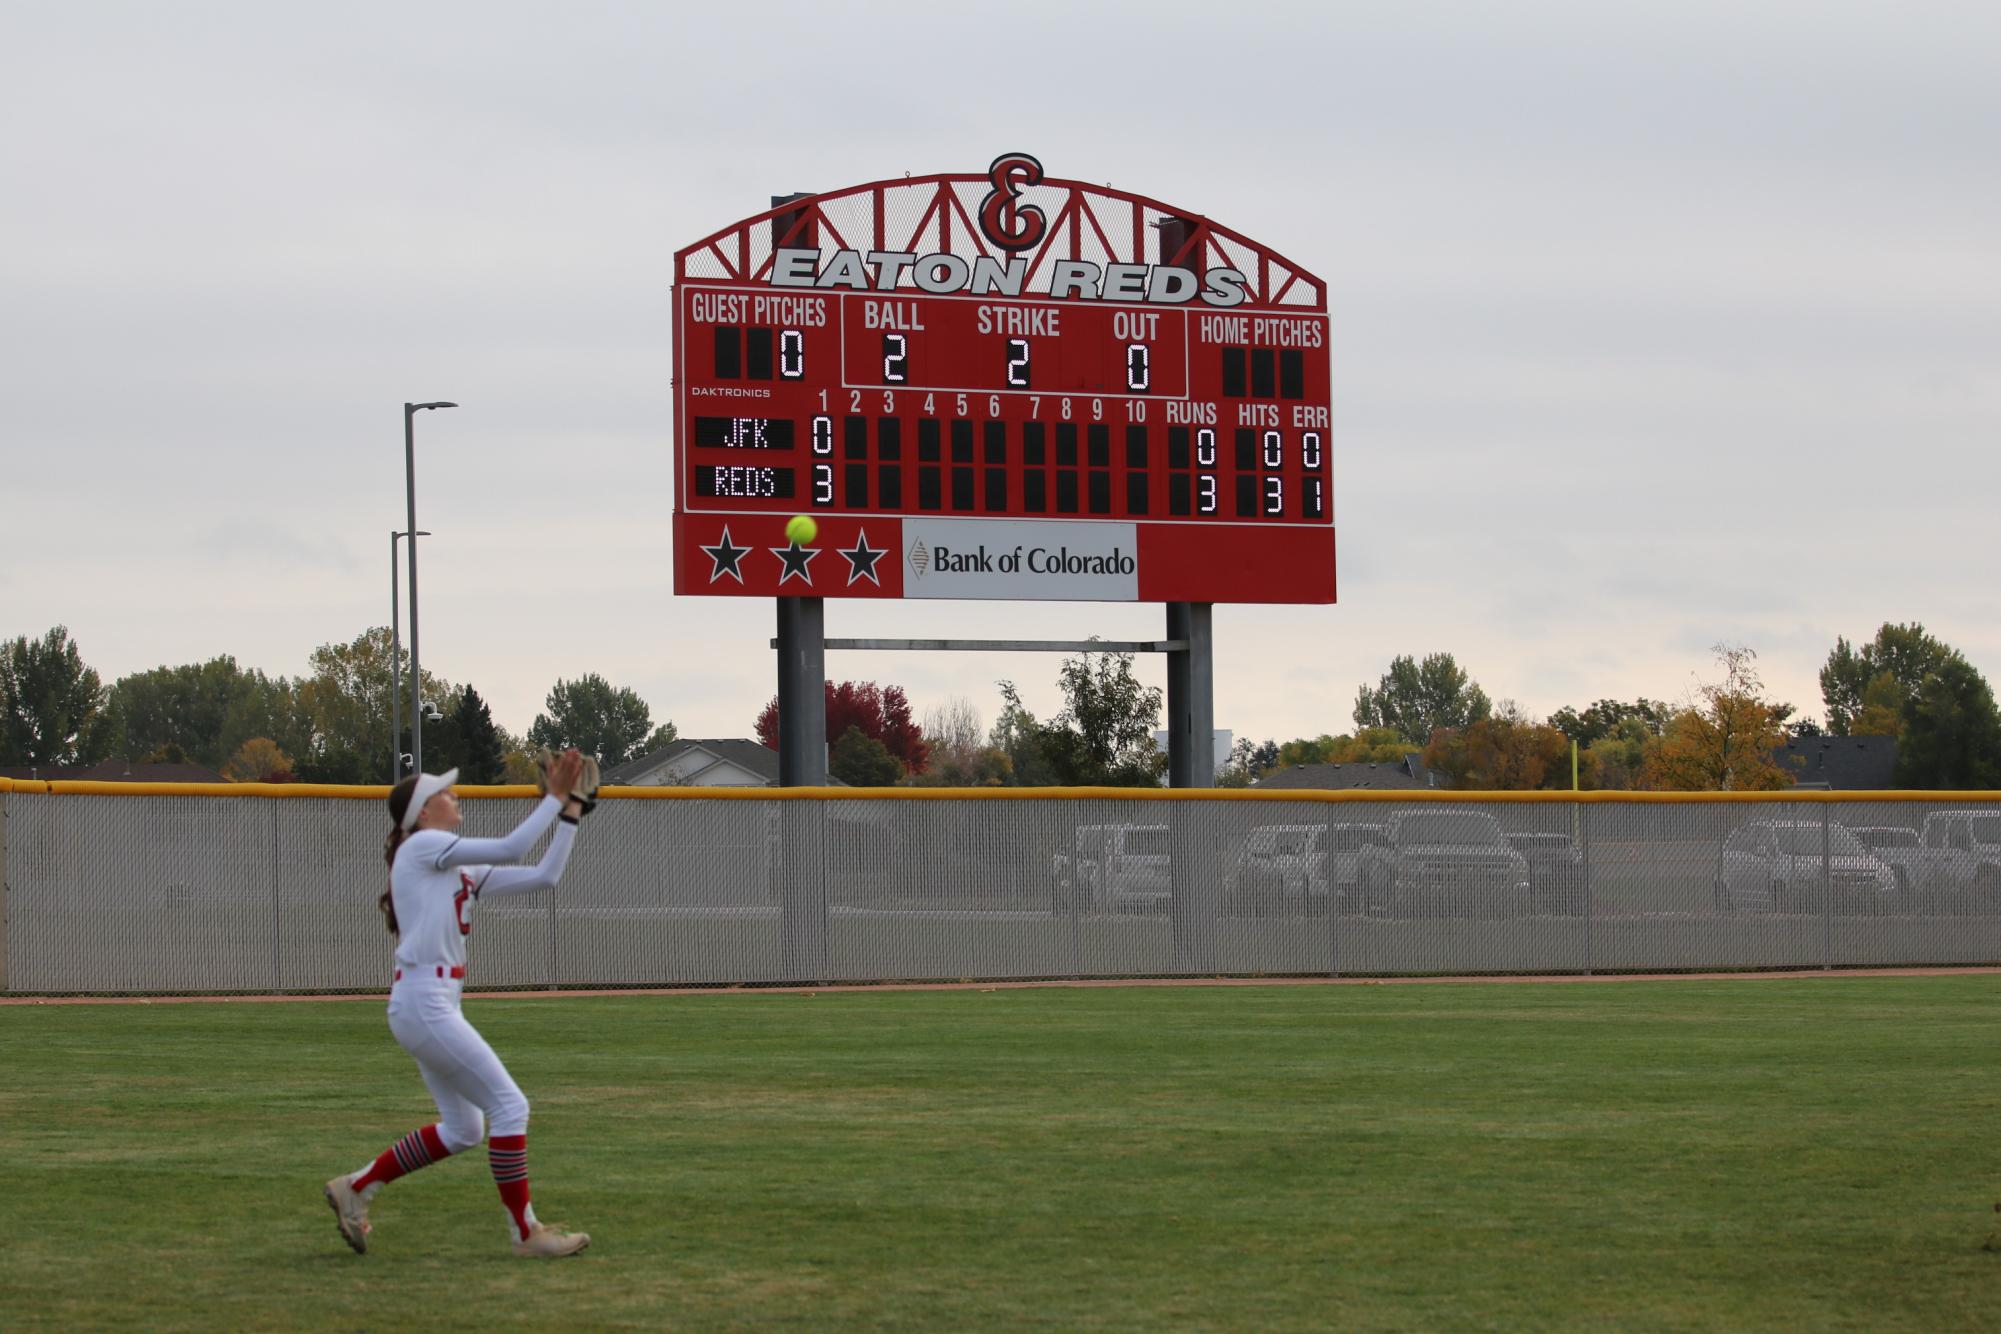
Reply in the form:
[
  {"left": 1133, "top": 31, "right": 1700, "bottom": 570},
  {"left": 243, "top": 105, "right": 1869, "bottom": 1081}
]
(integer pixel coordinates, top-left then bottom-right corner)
[{"left": 0, "top": 966, "right": 2001, "bottom": 1006}]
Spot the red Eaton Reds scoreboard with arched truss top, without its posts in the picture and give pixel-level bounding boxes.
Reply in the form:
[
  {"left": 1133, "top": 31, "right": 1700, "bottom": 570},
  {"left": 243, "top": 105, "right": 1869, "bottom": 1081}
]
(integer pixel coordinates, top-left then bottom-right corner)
[{"left": 674, "top": 154, "right": 1335, "bottom": 602}]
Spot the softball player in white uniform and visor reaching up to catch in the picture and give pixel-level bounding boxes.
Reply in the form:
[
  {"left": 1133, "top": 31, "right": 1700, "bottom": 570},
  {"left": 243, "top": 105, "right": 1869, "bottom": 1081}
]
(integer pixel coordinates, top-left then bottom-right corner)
[{"left": 326, "top": 750, "right": 590, "bottom": 1256}]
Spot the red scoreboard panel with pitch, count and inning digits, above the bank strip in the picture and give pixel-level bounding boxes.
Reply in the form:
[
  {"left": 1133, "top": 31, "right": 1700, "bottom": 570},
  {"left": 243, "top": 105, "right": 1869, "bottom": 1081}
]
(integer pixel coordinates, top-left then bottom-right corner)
[{"left": 682, "top": 288, "right": 1333, "bottom": 524}]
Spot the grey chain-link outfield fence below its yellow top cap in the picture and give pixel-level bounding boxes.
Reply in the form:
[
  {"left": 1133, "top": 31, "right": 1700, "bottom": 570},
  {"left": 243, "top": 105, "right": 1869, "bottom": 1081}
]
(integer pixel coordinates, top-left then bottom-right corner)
[{"left": 0, "top": 784, "right": 2001, "bottom": 994}]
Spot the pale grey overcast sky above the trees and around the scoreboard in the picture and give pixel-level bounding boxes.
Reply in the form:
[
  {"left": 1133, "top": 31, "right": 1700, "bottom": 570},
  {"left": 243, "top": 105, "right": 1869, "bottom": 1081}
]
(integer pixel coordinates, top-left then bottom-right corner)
[{"left": 0, "top": 0, "right": 2001, "bottom": 740}]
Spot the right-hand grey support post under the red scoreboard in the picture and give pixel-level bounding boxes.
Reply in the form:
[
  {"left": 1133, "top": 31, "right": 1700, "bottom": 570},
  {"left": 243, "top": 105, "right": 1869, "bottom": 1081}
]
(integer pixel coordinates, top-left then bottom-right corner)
[{"left": 1167, "top": 602, "right": 1223, "bottom": 972}]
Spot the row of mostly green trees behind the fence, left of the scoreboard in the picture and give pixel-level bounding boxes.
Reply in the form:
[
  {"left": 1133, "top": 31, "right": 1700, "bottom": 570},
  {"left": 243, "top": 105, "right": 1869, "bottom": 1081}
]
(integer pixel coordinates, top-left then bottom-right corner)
[{"left": 0, "top": 626, "right": 676, "bottom": 784}]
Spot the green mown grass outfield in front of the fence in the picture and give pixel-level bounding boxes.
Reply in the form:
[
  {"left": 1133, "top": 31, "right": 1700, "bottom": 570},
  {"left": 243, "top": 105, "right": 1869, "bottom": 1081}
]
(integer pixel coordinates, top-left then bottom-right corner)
[{"left": 0, "top": 976, "right": 2001, "bottom": 1330}]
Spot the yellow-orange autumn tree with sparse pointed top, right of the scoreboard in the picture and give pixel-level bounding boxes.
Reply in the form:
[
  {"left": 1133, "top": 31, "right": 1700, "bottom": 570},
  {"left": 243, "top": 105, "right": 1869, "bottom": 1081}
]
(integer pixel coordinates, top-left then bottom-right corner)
[{"left": 1641, "top": 644, "right": 1793, "bottom": 792}]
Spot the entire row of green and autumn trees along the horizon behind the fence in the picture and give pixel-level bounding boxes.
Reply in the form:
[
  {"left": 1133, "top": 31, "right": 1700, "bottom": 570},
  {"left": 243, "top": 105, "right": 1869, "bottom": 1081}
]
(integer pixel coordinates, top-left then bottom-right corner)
[{"left": 0, "top": 622, "right": 2001, "bottom": 792}]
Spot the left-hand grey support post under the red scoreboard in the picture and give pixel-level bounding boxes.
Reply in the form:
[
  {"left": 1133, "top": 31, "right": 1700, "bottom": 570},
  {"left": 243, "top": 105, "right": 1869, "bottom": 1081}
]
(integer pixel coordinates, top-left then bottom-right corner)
[{"left": 776, "top": 598, "right": 828, "bottom": 982}]
